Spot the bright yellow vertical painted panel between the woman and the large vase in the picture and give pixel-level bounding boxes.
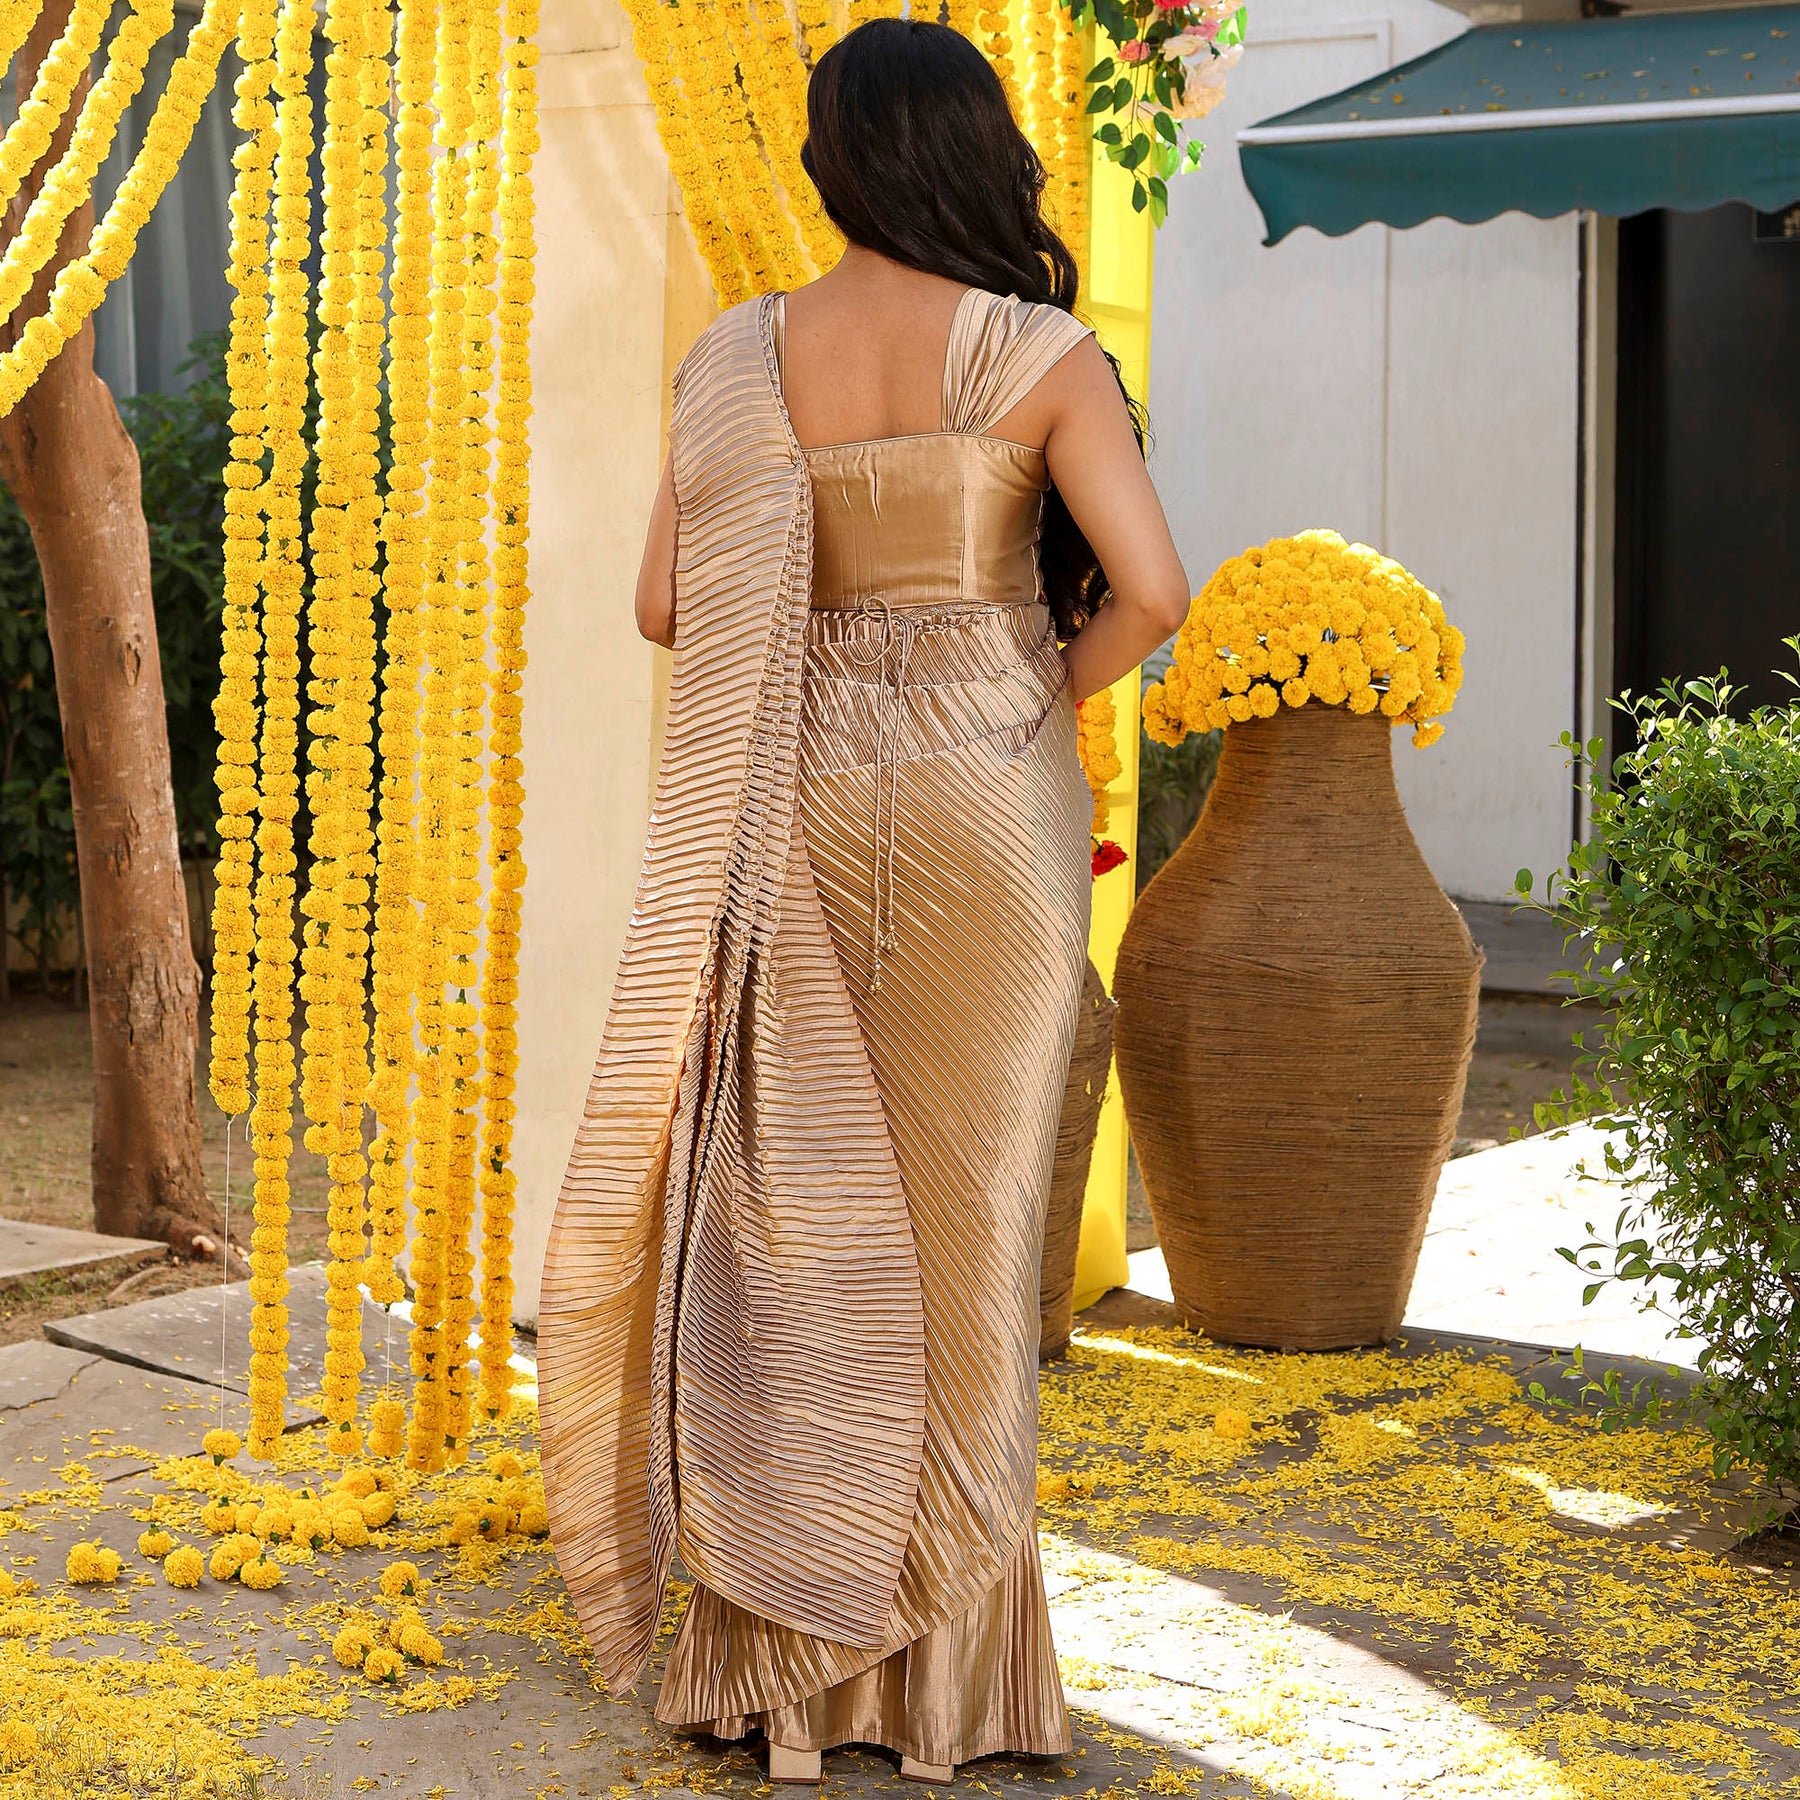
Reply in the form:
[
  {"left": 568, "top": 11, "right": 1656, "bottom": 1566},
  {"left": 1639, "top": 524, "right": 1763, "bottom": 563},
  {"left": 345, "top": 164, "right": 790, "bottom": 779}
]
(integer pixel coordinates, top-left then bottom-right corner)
[{"left": 1075, "top": 102, "right": 1156, "bottom": 1310}]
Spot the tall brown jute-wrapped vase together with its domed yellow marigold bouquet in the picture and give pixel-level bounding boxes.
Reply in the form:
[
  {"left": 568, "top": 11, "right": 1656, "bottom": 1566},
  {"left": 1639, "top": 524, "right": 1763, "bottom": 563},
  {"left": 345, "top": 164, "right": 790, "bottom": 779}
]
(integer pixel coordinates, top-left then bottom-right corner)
[{"left": 1114, "top": 531, "right": 1480, "bottom": 1348}]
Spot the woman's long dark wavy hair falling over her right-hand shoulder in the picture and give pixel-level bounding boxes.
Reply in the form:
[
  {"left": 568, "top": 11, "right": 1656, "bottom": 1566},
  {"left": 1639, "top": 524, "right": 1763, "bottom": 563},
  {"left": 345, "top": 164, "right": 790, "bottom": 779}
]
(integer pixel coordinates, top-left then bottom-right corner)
[{"left": 801, "top": 18, "right": 1143, "bottom": 637}]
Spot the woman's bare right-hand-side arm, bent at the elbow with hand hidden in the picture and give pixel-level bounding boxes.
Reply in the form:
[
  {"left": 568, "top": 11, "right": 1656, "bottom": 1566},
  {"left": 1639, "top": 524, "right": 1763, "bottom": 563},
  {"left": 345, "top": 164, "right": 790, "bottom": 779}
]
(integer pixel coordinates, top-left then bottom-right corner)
[{"left": 1019, "top": 338, "right": 1192, "bottom": 700}]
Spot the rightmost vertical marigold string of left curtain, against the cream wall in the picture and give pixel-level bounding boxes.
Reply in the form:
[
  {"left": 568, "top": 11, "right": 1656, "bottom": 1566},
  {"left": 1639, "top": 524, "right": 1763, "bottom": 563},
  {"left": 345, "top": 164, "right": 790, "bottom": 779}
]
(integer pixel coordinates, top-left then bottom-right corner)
[{"left": 481, "top": 0, "right": 538, "bottom": 1418}]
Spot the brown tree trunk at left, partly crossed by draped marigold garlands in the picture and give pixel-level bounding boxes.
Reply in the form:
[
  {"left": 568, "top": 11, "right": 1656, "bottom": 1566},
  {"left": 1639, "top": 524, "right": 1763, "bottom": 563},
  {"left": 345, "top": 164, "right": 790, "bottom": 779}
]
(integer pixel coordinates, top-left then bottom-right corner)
[{"left": 0, "top": 0, "right": 223, "bottom": 1256}]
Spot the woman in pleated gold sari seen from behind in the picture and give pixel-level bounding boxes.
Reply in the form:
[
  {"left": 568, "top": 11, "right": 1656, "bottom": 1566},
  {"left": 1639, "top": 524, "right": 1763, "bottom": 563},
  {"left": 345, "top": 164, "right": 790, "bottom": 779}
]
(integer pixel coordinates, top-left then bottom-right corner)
[{"left": 540, "top": 20, "right": 1188, "bottom": 1780}]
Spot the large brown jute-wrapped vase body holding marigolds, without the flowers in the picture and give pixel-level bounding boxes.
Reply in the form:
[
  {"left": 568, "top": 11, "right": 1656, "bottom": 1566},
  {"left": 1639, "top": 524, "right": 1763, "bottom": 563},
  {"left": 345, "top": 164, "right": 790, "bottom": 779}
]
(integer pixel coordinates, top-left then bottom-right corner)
[{"left": 1114, "top": 704, "right": 1481, "bottom": 1350}]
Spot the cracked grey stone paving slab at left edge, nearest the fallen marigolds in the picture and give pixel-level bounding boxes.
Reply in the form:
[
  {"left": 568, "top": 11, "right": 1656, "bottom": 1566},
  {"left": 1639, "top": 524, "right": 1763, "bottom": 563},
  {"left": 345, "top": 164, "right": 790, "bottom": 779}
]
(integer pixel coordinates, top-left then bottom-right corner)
[{"left": 0, "top": 1343, "right": 255, "bottom": 1503}]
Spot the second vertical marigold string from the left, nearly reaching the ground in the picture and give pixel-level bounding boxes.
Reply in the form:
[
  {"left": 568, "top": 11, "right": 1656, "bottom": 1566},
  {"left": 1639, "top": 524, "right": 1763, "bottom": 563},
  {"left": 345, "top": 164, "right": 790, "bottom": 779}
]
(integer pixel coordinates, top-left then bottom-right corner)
[{"left": 250, "top": 0, "right": 313, "bottom": 1456}]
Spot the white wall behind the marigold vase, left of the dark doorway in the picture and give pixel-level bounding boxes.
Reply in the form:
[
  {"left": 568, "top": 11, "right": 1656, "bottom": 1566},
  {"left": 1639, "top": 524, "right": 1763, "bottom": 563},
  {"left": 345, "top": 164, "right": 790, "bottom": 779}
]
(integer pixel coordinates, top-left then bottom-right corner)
[{"left": 1150, "top": 0, "right": 1579, "bottom": 900}]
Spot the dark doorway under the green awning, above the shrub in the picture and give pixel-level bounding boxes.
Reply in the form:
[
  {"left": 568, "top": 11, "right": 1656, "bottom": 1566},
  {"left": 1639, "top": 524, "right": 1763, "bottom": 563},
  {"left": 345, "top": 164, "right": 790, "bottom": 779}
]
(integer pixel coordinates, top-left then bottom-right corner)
[{"left": 1613, "top": 205, "right": 1800, "bottom": 707}]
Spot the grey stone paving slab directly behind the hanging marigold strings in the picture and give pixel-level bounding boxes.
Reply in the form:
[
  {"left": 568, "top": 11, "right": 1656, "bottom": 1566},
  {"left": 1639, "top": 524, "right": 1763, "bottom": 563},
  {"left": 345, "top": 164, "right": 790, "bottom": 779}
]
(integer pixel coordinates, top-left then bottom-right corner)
[{"left": 43, "top": 1262, "right": 407, "bottom": 1429}]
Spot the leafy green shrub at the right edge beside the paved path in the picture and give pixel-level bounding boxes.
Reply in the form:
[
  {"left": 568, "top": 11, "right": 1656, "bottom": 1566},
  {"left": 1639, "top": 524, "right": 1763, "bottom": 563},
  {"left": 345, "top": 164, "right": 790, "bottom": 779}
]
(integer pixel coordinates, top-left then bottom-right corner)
[{"left": 1519, "top": 655, "right": 1800, "bottom": 1481}]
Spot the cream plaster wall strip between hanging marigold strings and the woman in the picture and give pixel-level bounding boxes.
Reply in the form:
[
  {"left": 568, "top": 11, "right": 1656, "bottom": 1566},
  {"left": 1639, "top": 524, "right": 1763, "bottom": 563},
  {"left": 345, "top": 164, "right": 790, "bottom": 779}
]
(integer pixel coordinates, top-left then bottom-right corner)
[{"left": 515, "top": 0, "right": 680, "bottom": 1319}]
